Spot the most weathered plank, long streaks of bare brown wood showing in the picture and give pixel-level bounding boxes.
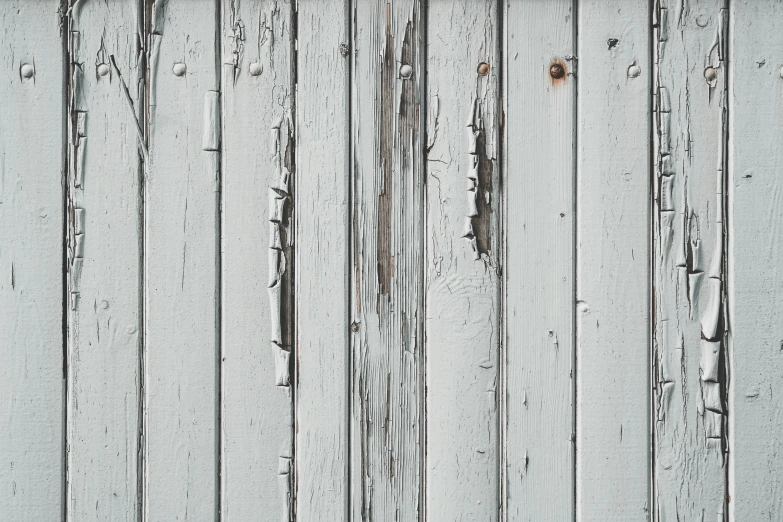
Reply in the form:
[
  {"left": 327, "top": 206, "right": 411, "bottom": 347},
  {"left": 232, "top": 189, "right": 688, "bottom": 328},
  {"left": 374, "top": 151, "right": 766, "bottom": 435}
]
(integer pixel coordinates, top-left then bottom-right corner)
[{"left": 350, "top": 0, "right": 425, "bottom": 520}]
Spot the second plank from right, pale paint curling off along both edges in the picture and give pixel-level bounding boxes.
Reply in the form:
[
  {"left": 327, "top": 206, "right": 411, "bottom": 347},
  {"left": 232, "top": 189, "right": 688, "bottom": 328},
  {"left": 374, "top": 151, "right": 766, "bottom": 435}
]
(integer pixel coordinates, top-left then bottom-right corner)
[{"left": 648, "top": 0, "right": 728, "bottom": 521}]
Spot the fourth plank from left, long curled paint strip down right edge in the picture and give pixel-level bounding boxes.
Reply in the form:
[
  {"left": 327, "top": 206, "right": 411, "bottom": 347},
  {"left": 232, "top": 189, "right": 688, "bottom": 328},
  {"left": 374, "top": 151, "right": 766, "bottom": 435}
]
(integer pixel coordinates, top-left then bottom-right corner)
[{"left": 221, "top": 0, "right": 296, "bottom": 521}]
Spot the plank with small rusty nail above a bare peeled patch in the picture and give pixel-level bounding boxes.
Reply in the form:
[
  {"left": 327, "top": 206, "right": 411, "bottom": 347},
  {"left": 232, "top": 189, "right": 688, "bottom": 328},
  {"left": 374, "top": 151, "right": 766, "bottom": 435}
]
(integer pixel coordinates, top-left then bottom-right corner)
[{"left": 425, "top": 0, "right": 502, "bottom": 521}]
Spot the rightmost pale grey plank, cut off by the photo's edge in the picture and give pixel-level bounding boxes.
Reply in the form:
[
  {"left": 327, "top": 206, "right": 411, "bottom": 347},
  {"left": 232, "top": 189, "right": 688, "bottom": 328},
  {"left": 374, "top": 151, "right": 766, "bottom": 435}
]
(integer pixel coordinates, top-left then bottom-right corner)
[{"left": 726, "top": 0, "right": 783, "bottom": 520}]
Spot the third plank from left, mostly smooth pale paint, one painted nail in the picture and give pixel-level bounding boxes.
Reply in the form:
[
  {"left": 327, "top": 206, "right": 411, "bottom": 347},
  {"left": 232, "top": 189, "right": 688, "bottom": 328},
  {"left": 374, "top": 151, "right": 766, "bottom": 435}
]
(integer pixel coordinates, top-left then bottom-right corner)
[{"left": 144, "top": 0, "right": 220, "bottom": 520}]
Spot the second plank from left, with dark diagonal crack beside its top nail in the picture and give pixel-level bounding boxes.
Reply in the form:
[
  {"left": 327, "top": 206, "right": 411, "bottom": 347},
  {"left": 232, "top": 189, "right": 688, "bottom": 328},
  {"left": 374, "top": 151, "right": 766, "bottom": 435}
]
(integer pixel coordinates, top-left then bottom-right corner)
[{"left": 67, "top": 0, "right": 142, "bottom": 521}]
